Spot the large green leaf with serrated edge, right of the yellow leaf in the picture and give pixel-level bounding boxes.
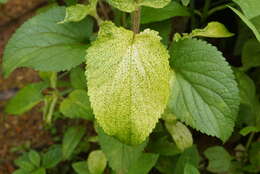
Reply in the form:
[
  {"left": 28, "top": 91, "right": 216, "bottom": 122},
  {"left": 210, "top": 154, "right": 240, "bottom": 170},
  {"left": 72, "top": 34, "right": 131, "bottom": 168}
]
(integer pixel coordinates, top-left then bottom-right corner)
[{"left": 168, "top": 39, "right": 239, "bottom": 141}]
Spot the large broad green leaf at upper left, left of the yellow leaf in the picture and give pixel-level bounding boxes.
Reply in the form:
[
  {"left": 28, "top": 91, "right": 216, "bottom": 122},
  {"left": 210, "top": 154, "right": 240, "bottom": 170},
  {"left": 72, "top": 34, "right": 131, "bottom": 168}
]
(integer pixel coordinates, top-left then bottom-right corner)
[{"left": 3, "top": 7, "right": 93, "bottom": 76}]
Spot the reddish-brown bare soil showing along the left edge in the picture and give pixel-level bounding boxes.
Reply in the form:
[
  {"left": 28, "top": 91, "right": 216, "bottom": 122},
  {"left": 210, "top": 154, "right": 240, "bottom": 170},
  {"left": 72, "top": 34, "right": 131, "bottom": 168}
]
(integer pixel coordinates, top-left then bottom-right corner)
[{"left": 0, "top": 0, "right": 52, "bottom": 174}]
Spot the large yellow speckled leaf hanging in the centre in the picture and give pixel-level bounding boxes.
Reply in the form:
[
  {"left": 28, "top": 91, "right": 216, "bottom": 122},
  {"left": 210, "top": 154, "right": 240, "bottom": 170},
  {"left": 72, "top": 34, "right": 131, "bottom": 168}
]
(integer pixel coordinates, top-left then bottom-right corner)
[{"left": 86, "top": 22, "right": 169, "bottom": 144}]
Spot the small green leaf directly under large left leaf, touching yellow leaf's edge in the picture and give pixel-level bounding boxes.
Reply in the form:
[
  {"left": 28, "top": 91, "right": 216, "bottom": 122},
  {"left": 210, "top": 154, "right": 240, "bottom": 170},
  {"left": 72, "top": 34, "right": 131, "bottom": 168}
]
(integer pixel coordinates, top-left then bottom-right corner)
[{"left": 70, "top": 66, "right": 87, "bottom": 89}]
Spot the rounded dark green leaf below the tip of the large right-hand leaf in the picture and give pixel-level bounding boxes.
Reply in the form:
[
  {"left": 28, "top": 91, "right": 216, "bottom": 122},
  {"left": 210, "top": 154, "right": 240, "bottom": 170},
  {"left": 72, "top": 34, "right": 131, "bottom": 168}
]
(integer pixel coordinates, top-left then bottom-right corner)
[{"left": 204, "top": 146, "right": 232, "bottom": 173}]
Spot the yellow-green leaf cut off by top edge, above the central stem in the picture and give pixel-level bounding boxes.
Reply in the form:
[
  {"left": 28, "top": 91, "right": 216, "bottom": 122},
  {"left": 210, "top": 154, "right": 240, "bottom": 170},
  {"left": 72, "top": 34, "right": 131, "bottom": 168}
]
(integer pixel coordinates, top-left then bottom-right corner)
[{"left": 107, "top": 0, "right": 171, "bottom": 13}]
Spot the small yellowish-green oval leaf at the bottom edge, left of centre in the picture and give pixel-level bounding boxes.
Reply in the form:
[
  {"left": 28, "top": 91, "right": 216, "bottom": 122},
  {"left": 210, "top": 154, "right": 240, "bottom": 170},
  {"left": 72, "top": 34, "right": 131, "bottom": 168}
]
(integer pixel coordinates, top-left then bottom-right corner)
[{"left": 87, "top": 150, "right": 107, "bottom": 174}]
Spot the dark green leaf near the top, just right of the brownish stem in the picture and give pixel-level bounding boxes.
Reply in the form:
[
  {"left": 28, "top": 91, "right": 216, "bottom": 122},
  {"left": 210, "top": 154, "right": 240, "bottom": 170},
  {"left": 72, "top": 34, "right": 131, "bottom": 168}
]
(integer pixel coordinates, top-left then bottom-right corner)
[{"left": 141, "top": 1, "right": 190, "bottom": 24}]
